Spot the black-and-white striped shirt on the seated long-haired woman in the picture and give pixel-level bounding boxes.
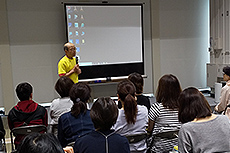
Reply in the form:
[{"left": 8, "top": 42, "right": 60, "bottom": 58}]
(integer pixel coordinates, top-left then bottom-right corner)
[{"left": 148, "top": 102, "right": 181, "bottom": 153}]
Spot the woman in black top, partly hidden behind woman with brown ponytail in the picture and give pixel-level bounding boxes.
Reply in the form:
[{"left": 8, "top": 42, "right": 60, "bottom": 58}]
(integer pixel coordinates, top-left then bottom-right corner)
[{"left": 128, "top": 72, "right": 150, "bottom": 110}]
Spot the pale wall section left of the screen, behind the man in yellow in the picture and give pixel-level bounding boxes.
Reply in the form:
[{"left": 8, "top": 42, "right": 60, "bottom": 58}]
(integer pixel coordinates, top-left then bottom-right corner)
[{"left": 6, "top": 0, "right": 66, "bottom": 103}]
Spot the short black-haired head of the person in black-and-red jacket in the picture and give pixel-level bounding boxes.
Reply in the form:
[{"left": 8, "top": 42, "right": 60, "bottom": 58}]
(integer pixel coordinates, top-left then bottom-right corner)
[{"left": 16, "top": 82, "right": 33, "bottom": 101}]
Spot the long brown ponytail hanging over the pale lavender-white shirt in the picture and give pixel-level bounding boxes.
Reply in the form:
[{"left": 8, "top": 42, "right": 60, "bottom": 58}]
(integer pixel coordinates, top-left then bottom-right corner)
[{"left": 124, "top": 94, "right": 137, "bottom": 124}]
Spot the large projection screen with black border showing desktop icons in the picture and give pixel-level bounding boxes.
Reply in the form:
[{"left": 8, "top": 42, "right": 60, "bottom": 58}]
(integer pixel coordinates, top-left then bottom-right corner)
[{"left": 64, "top": 3, "right": 144, "bottom": 79}]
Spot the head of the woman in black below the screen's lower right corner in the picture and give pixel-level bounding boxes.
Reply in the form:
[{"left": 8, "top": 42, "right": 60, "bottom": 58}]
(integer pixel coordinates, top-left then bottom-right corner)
[{"left": 128, "top": 72, "right": 144, "bottom": 94}]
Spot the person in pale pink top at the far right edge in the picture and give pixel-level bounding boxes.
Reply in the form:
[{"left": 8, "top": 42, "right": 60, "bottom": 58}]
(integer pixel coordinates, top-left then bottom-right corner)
[{"left": 214, "top": 66, "right": 230, "bottom": 113}]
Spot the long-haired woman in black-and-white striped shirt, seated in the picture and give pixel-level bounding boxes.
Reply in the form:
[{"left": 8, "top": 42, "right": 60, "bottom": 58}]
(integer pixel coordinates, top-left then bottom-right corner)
[{"left": 148, "top": 74, "right": 181, "bottom": 153}]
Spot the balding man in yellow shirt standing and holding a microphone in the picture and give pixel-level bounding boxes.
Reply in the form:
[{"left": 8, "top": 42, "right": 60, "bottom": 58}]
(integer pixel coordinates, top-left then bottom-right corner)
[{"left": 58, "top": 42, "right": 81, "bottom": 83}]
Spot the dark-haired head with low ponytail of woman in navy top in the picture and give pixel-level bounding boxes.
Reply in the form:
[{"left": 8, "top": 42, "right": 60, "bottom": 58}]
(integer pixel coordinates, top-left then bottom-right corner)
[{"left": 69, "top": 82, "right": 91, "bottom": 117}]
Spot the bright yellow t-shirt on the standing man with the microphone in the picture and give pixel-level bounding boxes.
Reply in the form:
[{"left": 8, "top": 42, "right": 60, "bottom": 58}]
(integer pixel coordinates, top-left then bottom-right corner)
[{"left": 58, "top": 56, "right": 78, "bottom": 83}]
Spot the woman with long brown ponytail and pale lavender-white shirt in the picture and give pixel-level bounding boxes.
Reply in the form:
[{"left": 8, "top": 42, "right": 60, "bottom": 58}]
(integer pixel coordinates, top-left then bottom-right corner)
[{"left": 113, "top": 80, "right": 148, "bottom": 153}]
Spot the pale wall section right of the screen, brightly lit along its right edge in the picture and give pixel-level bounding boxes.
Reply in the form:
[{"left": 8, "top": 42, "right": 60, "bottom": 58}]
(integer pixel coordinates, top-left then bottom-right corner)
[{"left": 159, "top": 0, "right": 209, "bottom": 88}]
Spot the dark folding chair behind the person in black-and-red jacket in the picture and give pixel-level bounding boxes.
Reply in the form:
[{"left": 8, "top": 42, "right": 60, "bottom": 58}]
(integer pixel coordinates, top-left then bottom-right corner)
[{"left": 10, "top": 125, "right": 47, "bottom": 153}]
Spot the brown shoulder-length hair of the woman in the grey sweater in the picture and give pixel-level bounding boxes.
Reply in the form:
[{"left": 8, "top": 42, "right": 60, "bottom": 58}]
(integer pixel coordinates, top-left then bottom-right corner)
[{"left": 178, "top": 87, "right": 212, "bottom": 123}]
